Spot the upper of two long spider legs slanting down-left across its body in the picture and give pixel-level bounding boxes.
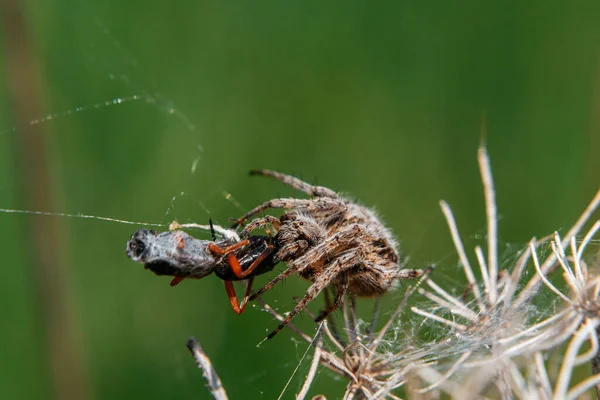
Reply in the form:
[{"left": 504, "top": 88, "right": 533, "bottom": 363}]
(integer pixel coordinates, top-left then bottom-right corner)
[{"left": 250, "top": 225, "right": 360, "bottom": 300}]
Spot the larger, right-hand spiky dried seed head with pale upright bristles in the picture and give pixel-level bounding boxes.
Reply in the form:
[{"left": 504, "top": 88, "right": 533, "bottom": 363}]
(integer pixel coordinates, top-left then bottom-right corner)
[{"left": 412, "top": 148, "right": 600, "bottom": 399}]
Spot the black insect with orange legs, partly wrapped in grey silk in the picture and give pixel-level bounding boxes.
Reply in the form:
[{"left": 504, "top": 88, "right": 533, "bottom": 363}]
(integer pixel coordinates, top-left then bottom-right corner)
[{"left": 126, "top": 223, "right": 275, "bottom": 314}]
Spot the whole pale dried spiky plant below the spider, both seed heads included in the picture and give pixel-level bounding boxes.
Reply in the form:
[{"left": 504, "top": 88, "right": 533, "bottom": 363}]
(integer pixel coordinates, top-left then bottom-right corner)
[{"left": 185, "top": 147, "right": 600, "bottom": 399}]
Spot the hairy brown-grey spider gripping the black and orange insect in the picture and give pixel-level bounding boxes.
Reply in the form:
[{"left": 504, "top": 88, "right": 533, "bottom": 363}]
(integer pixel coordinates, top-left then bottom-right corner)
[{"left": 233, "top": 170, "right": 425, "bottom": 339}]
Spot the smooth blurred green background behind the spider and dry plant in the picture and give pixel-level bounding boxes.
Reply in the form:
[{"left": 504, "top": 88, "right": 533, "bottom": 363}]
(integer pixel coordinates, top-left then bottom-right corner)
[{"left": 0, "top": 0, "right": 600, "bottom": 399}]
